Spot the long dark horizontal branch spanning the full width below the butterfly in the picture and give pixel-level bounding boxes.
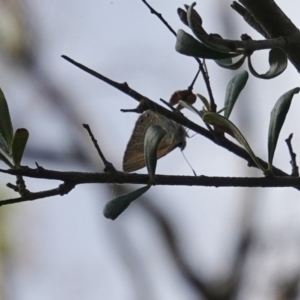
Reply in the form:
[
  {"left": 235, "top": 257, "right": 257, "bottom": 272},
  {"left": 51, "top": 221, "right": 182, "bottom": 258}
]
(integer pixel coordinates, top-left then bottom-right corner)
[{"left": 0, "top": 167, "right": 300, "bottom": 189}]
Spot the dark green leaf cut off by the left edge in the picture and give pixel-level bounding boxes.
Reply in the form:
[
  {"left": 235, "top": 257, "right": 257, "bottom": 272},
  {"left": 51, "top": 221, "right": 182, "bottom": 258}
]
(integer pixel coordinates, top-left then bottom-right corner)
[{"left": 0, "top": 89, "right": 13, "bottom": 153}]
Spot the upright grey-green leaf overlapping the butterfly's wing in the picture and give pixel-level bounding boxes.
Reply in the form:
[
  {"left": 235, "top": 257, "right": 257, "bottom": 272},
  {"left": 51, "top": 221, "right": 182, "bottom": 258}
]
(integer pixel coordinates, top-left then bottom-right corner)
[{"left": 144, "top": 125, "right": 166, "bottom": 181}]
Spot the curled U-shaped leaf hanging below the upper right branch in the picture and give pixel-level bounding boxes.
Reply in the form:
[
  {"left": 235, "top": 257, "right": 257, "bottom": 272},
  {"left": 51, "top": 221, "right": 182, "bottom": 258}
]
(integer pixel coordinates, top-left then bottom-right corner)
[{"left": 248, "top": 48, "right": 287, "bottom": 79}]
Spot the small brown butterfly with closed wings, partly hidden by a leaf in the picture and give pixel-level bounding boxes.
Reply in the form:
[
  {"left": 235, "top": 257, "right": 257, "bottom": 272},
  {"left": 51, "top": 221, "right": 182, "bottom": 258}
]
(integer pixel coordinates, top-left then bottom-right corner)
[{"left": 123, "top": 110, "right": 187, "bottom": 172}]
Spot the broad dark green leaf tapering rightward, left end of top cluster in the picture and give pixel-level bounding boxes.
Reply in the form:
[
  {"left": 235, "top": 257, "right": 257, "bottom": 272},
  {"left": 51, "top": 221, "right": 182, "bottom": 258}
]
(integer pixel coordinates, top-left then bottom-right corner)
[{"left": 175, "top": 29, "right": 237, "bottom": 59}]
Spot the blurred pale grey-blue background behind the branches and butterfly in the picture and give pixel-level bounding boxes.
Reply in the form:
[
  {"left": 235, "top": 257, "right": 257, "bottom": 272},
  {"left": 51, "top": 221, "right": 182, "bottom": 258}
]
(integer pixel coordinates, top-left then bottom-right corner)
[{"left": 0, "top": 0, "right": 300, "bottom": 300}]
